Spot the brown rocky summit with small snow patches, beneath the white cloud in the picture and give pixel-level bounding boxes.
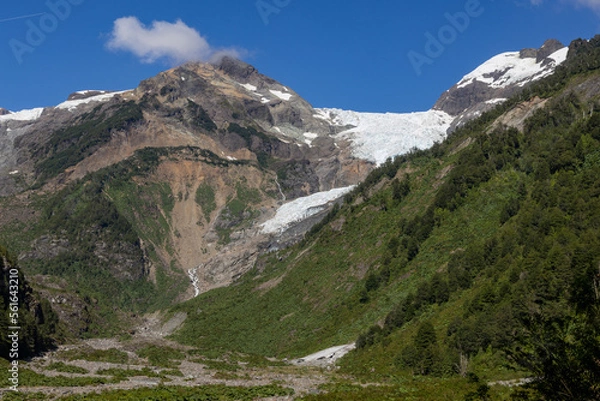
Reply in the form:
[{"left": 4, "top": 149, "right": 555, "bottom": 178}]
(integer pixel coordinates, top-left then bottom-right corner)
[{"left": 136, "top": 57, "right": 331, "bottom": 143}]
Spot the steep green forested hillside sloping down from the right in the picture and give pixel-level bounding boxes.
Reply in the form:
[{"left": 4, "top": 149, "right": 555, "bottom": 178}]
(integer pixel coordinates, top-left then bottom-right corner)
[{"left": 169, "top": 37, "right": 600, "bottom": 400}]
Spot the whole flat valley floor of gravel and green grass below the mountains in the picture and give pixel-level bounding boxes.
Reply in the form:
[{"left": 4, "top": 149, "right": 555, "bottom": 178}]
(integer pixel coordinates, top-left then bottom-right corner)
[{"left": 0, "top": 330, "right": 522, "bottom": 401}]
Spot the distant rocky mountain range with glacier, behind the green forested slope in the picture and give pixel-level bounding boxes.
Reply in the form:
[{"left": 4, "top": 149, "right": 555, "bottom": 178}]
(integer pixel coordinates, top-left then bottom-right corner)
[{"left": 0, "top": 38, "right": 576, "bottom": 336}]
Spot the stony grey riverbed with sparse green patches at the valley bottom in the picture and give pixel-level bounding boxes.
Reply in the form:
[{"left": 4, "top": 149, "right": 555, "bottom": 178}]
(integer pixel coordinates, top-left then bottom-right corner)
[{"left": 0, "top": 337, "right": 332, "bottom": 400}]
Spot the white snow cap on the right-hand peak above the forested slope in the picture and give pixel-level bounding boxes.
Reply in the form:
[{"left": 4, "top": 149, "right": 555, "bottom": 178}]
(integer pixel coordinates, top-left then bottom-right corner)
[{"left": 458, "top": 47, "right": 569, "bottom": 88}]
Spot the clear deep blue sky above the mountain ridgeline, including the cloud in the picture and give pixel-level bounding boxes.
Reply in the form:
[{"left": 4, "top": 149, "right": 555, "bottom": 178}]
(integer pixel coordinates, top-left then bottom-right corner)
[{"left": 0, "top": 0, "right": 600, "bottom": 112}]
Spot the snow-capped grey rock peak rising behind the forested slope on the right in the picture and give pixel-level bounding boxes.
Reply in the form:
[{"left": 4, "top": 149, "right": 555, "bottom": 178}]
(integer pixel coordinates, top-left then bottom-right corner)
[{"left": 433, "top": 39, "right": 568, "bottom": 130}]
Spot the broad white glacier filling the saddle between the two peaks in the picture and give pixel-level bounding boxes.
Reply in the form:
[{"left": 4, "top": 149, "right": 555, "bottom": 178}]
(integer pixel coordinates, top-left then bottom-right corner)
[{"left": 315, "top": 109, "right": 454, "bottom": 165}]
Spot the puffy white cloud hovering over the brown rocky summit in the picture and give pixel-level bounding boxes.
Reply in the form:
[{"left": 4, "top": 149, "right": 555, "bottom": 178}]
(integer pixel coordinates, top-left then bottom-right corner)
[{"left": 106, "top": 17, "right": 241, "bottom": 64}]
